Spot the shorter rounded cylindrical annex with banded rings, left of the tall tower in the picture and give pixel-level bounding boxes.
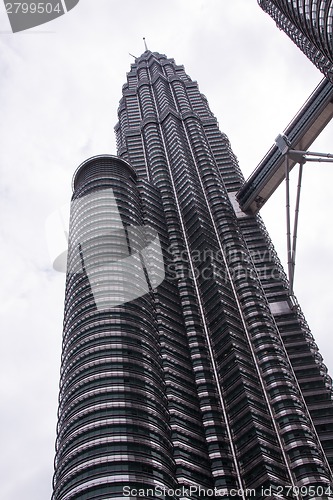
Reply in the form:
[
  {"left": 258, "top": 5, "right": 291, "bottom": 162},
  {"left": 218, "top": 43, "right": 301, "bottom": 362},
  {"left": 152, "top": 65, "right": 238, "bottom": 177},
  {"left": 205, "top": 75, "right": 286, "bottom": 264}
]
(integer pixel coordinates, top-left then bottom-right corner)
[{"left": 53, "top": 155, "right": 175, "bottom": 500}]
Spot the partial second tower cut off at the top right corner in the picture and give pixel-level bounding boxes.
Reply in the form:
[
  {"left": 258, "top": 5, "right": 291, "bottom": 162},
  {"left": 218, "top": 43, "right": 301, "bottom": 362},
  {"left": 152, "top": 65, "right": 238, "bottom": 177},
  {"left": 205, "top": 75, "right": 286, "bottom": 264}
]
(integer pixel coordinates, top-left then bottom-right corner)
[{"left": 258, "top": 0, "right": 333, "bottom": 81}]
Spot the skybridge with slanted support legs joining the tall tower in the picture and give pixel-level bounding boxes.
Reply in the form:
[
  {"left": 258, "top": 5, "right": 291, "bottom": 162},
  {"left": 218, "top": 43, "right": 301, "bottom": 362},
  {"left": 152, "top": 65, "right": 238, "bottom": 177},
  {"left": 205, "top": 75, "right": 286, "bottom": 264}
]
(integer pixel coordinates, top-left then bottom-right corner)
[{"left": 236, "top": 78, "right": 333, "bottom": 294}]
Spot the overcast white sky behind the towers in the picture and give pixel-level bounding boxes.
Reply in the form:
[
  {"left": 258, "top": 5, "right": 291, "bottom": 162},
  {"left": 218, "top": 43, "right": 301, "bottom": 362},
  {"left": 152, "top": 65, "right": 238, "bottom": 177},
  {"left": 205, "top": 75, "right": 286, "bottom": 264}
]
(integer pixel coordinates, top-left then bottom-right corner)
[{"left": 0, "top": 0, "right": 333, "bottom": 500}]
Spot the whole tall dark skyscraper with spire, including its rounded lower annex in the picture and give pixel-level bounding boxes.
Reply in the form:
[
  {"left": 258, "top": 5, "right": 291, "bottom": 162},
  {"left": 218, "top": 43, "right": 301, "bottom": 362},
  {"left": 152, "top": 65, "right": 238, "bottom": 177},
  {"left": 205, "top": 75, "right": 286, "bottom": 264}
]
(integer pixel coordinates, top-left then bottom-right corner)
[{"left": 53, "top": 50, "right": 333, "bottom": 500}]
